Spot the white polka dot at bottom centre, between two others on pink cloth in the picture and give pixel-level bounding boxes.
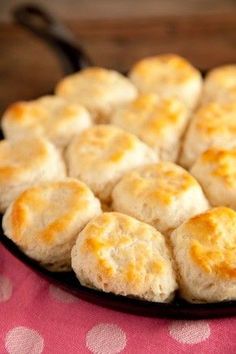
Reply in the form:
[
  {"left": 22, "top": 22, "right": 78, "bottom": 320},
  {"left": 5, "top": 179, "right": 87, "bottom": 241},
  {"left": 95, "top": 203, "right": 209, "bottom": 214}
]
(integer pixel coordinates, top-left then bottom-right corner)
[{"left": 86, "top": 323, "right": 126, "bottom": 354}]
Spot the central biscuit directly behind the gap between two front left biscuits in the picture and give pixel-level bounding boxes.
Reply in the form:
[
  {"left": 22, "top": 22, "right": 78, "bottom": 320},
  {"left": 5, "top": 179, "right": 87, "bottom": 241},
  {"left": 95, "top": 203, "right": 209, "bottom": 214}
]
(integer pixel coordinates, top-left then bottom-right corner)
[{"left": 65, "top": 125, "right": 157, "bottom": 204}]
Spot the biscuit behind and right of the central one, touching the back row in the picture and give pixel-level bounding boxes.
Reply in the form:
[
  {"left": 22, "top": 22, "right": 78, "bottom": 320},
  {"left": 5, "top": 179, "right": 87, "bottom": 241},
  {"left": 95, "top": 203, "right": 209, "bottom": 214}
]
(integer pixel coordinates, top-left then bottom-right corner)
[{"left": 110, "top": 93, "right": 189, "bottom": 161}]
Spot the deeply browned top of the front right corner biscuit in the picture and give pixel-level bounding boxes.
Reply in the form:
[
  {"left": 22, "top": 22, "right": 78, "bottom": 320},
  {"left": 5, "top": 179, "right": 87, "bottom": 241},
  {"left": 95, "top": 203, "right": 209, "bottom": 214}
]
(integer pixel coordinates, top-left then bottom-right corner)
[{"left": 184, "top": 207, "right": 236, "bottom": 279}]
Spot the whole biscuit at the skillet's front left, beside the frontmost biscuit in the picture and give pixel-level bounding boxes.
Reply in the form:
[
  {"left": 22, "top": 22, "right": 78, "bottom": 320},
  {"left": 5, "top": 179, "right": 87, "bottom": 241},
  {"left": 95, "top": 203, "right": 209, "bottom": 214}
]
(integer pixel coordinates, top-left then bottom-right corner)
[{"left": 3, "top": 178, "right": 101, "bottom": 271}]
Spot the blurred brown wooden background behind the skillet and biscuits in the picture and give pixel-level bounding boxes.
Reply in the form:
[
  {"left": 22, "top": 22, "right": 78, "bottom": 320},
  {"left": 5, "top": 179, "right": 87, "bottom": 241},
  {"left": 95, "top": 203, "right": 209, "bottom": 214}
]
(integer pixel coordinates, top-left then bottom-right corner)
[{"left": 0, "top": 0, "right": 236, "bottom": 113}]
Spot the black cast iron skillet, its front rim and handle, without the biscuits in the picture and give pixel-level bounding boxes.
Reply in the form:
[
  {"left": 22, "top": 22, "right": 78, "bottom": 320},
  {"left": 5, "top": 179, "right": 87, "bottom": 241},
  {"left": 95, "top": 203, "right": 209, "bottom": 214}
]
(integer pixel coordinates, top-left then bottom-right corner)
[{"left": 0, "top": 5, "right": 236, "bottom": 319}]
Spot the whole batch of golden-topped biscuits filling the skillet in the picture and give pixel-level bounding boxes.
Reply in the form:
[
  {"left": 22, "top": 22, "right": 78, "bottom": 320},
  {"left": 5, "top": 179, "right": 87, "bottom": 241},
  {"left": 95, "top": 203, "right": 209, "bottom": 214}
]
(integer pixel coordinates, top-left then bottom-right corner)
[{"left": 0, "top": 54, "right": 236, "bottom": 303}]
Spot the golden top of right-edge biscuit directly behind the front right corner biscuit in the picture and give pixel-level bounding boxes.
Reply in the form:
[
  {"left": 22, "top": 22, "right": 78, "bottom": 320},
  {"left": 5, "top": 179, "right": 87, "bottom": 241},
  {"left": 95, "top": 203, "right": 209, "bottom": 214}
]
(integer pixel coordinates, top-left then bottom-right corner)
[{"left": 200, "top": 148, "right": 236, "bottom": 188}]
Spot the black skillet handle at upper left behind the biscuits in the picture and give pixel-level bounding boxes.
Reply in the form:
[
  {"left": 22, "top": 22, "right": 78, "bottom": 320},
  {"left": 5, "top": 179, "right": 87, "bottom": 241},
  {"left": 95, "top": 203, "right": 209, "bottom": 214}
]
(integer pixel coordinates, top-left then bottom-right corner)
[{"left": 13, "top": 4, "right": 92, "bottom": 74}]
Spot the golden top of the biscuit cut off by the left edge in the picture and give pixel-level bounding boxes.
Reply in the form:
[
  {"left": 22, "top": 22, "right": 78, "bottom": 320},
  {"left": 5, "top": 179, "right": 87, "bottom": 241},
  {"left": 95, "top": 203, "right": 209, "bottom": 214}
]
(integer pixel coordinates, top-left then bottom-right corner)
[{"left": 0, "top": 138, "right": 52, "bottom": 183}]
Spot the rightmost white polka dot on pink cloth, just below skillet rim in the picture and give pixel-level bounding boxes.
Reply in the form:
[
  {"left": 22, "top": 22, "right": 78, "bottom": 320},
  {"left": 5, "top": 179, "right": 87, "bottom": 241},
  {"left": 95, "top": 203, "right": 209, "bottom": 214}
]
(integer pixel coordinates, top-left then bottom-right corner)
[{"left": 169, "top": 321, "right": 211, "bottom": 344}]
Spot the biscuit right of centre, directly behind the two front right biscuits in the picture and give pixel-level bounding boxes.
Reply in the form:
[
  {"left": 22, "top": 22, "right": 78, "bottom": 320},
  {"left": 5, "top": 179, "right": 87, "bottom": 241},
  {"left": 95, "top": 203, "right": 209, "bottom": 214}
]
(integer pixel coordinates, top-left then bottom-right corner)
[{"left": 112, "top": 162, "right": 209, "bottom": 235}]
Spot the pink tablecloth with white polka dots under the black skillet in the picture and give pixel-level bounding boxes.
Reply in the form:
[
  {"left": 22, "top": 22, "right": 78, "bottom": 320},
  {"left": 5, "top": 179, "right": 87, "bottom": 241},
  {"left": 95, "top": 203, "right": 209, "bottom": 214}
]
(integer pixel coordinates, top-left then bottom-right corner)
[{"left": 0, "top": 246, "right": 236, "bottom": 354}]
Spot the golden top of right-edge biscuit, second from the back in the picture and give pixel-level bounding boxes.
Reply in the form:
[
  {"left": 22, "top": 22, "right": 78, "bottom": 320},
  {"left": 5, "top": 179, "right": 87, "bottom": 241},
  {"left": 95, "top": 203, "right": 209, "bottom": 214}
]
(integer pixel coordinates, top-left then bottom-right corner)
[{"left": 194, "top": 102, "right": 236, "bottom": 136}]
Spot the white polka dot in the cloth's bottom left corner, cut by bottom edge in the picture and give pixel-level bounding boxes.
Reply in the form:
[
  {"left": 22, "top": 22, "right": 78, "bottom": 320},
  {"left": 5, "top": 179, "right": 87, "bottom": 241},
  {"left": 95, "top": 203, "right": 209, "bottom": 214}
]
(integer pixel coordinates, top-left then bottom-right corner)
[{"left": 5, "top": 327, "right": 44, "bottom": 354}]
